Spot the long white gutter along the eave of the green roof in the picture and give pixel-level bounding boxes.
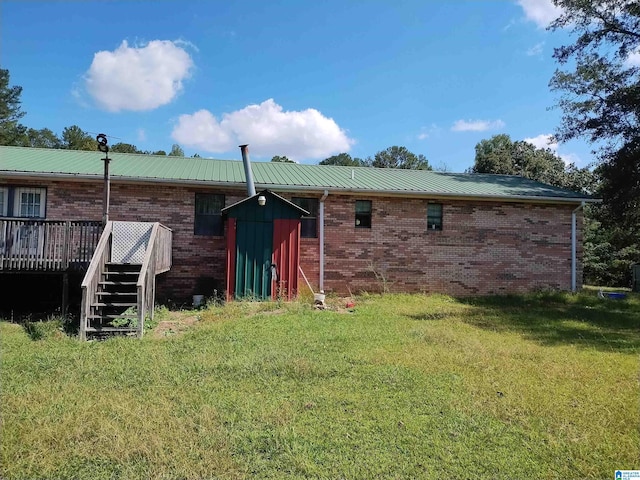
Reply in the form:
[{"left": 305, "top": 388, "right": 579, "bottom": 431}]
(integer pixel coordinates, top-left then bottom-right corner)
[{"left": 2, "top": 171, "right": 602, "bottom": 204}]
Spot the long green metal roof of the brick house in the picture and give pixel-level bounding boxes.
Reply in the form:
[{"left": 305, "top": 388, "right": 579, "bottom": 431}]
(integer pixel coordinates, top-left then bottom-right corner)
[{"left": 0, "top": 146, "right": 595, "bottom": 202}]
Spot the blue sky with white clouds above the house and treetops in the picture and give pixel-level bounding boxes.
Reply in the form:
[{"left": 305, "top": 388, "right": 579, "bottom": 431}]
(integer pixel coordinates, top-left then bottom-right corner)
[{"left": 0, "top": 0, "right": 592, "bottom": 171}]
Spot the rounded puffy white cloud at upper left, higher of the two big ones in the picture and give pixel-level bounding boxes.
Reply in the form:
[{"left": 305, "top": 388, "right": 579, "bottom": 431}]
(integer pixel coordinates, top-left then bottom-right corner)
[{"left": 85, "top": 40, "right": 193, "bottom": 112}]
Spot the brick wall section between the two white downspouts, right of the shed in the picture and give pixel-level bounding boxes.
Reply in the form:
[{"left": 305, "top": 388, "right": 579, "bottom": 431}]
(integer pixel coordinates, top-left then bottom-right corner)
[{"left": 318, "top": 195, "right": 582, "bottom": 295}]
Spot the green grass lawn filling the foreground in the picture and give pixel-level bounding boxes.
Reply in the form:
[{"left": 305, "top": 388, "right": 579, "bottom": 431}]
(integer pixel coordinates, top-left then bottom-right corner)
[{"left": 0, "top": 293, "right": 640, "bottom": 479}]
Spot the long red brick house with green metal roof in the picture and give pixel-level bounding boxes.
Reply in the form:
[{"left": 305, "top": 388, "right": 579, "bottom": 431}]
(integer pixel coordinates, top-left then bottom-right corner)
[{"left": 0, "top": 147, "right": 594, "bottom": 301}]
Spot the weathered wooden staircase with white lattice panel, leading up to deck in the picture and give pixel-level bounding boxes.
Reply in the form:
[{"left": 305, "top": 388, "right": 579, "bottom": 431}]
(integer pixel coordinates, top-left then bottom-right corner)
[{"left": 80, "top": 222, "right": 172, "bottom": 340}]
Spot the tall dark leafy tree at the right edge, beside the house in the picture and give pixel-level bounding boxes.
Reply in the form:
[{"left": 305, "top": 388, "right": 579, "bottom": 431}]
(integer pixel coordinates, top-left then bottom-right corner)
[{"left": 549, "top": 0, "right": 640, "bottom": 286}]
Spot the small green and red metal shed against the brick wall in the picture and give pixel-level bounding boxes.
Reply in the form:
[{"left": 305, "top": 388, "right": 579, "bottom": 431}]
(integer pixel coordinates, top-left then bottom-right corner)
[{"left": 222, "top": 190, "right": 308, "bottom": 300}]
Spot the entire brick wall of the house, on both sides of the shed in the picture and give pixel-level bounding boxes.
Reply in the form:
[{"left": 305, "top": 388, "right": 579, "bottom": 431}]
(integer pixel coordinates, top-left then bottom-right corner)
[{"left": 0, "top": 180, "right": 582, "bottom": 302}]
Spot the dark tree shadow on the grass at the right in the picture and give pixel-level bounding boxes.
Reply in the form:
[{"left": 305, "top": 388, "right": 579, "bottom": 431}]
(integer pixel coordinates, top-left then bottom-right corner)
[{"left": 460, "top": 293, "right": 640, "bottom": 353}]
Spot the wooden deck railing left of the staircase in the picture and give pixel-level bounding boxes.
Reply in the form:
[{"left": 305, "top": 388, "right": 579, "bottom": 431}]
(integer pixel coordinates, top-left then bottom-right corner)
[{"left": 0, "top": 218, "right": 102, "bottom": 272}]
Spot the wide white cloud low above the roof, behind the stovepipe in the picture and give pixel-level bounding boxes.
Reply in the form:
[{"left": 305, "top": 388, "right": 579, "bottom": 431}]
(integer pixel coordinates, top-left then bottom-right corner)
[{"left": 171, "top": 98, "right": 355, "bottom": 160}]
